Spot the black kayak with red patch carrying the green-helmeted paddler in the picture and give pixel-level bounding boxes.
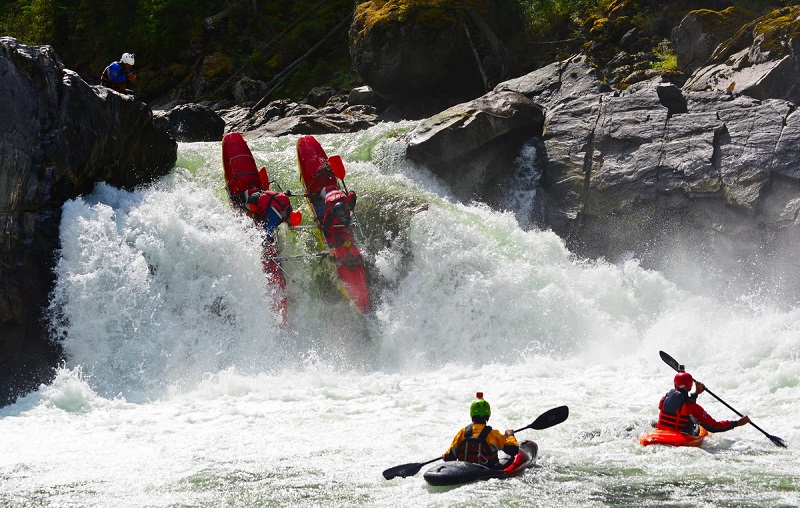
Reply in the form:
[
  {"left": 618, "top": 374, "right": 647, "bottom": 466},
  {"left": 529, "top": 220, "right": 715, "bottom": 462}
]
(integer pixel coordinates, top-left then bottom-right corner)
[{"left": 422, "top": 441, "right": 539, "bottom": 486}]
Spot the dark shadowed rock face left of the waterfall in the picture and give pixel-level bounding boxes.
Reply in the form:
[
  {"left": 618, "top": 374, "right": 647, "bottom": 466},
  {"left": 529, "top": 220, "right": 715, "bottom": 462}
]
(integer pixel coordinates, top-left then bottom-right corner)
[{"left": 0, "top": 37, "right": 177, "bottom": 405}]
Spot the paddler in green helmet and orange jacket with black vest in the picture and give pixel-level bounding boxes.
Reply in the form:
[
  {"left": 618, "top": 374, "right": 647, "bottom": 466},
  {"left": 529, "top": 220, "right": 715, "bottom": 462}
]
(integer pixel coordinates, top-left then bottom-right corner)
[{"left": 442, "top": 392, "right": 519, "bottom": 469}]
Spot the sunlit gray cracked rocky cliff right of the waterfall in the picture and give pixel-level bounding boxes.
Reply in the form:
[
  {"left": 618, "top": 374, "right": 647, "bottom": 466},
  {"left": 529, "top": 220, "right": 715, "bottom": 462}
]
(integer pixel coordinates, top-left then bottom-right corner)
[{"left": 408, "top": 7, "right": 800, "bottom": 299}]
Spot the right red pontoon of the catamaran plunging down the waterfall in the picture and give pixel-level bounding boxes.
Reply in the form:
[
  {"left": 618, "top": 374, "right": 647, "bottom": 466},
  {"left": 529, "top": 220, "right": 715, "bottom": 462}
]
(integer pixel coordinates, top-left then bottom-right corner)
[{"left": 297, "top": 136, "right": 372, "bottom": 314}]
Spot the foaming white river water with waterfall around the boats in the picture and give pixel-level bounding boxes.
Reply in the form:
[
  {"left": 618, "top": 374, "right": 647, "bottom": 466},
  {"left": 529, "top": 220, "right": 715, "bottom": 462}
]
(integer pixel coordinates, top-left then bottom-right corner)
[{"left": 0, "top": 124, "right": 800, "bottom": 507}]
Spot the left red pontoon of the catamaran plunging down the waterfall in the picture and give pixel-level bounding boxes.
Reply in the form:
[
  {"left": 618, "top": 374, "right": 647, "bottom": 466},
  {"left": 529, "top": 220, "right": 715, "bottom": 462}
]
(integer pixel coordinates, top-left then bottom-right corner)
[{"left": 222, "top": 132, "right": 286, "bottom": 324}]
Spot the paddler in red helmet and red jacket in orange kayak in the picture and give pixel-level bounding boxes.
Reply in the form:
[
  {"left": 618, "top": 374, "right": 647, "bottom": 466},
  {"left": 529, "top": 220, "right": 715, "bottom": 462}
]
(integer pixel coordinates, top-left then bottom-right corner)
[{"left": 656, "top": 372, "right": 750, "bottom": 436}]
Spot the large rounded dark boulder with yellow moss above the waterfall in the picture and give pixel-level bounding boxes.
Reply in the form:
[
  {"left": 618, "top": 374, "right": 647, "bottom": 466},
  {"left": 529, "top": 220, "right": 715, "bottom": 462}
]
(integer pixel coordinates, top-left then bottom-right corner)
[{"left": 350, "top": 0, "right": 524, "bottom": 101}]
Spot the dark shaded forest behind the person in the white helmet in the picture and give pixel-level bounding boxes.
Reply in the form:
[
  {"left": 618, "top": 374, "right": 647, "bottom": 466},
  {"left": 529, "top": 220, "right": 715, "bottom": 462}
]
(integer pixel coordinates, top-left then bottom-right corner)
[{"left": 0, "top": 0, "right": 353, "bottom": 100}]
